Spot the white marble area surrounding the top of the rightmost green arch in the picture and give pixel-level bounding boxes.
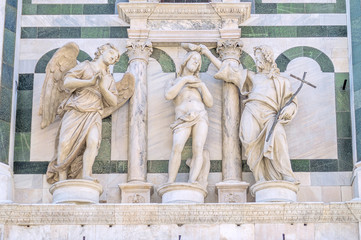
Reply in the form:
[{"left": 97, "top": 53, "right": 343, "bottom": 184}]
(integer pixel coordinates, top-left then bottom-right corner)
[{"left": 242, "top": 37, "right": 349, "bottom": 72}]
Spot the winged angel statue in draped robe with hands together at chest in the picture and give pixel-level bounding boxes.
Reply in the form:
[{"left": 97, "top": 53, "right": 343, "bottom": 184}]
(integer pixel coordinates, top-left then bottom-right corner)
[{"left": 39, "top": 42, "right": 135, "bottom": 184}]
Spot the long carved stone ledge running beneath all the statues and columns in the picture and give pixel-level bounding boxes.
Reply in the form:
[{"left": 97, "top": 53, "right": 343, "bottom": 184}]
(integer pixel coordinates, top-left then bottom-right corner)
[{"left": 0, "top": 202, "right": 361, "bottom": 225}]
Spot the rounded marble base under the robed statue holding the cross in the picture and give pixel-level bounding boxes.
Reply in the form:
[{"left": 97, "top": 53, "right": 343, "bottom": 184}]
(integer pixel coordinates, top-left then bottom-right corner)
[{"left": 251, "top": 180, "right": 299, "bottom": 202}]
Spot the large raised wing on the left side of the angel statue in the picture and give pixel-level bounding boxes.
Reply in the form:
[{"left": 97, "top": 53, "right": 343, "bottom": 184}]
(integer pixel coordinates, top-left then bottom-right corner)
[{"left": 39, "top": 42, "right": 79, "bottom": 129}]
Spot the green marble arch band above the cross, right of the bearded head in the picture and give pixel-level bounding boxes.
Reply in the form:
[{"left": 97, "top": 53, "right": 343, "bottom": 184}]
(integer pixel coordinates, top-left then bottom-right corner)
[{"left": 276, "top": 46, "right": 335, "bottom": 72}]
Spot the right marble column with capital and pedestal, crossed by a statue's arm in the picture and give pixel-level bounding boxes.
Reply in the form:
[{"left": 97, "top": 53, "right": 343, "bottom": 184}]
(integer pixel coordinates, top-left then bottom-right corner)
[{"left": 217, "top": 39, "right": 248, "bottom": 202}]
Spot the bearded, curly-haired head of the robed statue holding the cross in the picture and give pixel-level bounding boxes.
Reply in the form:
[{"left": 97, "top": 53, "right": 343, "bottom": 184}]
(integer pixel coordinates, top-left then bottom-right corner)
[{"left": 253, "top": 45, "right": 279, "bottom": 72}]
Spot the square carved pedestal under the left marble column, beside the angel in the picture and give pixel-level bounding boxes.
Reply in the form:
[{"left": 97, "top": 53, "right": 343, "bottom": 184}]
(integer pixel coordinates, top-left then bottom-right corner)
[{"left": 118, "top": 182, "right": 153, "bottom": 203}]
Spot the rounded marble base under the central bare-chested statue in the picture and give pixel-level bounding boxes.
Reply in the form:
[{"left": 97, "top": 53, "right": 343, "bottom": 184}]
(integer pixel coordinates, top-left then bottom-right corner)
[{"left": 158, "top": 183, "right": 207, "bottom": 203}]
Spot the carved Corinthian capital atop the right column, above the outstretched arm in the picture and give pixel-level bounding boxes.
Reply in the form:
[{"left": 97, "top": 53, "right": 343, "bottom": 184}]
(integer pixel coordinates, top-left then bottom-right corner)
[{"left": 217, "top": 39, "right": 243, "bottom": 61}]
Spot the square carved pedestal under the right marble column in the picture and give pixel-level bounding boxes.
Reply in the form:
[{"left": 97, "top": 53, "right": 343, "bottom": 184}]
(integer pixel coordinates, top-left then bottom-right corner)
[{"left": 216, "top": 181, "right": 249, "bottom": 203}]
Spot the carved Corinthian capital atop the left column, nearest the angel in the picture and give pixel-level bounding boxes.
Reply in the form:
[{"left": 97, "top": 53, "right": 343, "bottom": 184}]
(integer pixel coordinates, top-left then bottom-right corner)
[{"left": 126, "top": 40, "right": 153, "bottom": 62}]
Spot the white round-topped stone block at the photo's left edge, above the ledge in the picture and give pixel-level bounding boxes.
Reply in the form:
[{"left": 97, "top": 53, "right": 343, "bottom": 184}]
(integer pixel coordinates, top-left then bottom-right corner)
[{"left": 0, "top": 163, "right": 14, "bottom": 203}]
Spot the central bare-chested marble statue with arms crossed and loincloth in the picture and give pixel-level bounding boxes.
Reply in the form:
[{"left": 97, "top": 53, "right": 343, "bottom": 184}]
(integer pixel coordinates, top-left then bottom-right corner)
[{"left": 165, "top": 44, "right": 213, "bottom": 188}]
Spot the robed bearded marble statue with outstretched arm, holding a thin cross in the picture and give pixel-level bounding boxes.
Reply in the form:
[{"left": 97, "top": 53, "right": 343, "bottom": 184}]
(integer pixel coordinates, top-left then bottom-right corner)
[{"left": 200, "top": 45, "right": 297, "bottom": 182}]
